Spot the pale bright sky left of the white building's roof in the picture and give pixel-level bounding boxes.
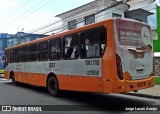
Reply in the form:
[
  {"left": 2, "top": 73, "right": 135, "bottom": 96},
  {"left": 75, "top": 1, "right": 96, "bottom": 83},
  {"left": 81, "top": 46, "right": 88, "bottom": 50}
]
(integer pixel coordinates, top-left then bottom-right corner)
[{"left": 0, "top": 0, "right": 94, "bottom": 34}]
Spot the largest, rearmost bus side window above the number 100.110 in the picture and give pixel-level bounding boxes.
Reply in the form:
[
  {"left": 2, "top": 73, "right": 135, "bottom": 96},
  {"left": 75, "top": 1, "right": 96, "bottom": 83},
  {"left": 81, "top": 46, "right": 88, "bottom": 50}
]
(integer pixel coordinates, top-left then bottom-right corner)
[{"left": 80, "top": 27, "right": 106, "bottom": 58}]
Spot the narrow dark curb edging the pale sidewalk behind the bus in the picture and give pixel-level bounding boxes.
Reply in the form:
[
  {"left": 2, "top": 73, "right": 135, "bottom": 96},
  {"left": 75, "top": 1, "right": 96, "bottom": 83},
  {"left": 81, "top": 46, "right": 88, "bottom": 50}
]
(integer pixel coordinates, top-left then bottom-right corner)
[{"left": 125, "top": 93, "right": 160, "bottom": 99}]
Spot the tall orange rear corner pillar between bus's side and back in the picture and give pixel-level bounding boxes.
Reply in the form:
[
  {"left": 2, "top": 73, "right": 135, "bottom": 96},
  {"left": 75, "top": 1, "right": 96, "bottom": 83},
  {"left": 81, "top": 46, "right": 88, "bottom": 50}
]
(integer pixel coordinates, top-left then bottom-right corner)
[{"left": 102, "top": 20, "right": 116, "bottom": 93}]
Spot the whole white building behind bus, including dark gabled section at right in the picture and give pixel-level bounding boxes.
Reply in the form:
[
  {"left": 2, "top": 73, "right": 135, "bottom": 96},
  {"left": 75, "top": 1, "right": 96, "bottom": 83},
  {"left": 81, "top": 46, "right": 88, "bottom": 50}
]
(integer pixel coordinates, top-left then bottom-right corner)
[{"left": 56, "top": 0, "right": 154, "bottom": 30}]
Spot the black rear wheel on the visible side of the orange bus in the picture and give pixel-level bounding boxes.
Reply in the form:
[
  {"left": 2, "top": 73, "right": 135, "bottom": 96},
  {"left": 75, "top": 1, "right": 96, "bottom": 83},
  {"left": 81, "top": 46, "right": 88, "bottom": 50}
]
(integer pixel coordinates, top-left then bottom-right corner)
[{"left": 47, "top": 76, "right": 59, "bottom": 97}]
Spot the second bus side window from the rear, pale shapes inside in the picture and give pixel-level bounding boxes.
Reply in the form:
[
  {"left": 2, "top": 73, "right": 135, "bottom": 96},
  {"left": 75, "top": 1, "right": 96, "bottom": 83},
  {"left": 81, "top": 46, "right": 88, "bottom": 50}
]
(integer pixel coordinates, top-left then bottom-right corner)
[{"left": 63, "top": 34, "right": 79, "bottom": 59}]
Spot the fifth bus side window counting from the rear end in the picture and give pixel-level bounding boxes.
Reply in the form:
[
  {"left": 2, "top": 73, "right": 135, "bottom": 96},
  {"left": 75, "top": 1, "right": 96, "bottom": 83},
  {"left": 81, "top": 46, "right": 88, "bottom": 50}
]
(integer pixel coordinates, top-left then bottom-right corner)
[{"left": 29, "top": 44, "right": 37, "bottom": 62}]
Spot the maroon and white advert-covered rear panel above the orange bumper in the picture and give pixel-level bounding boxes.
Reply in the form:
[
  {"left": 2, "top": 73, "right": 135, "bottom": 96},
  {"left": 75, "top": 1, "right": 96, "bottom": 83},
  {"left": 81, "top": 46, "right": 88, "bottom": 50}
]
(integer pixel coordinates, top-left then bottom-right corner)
[{"left": 116, "top": 19, "right": 153, "bottom": 79}]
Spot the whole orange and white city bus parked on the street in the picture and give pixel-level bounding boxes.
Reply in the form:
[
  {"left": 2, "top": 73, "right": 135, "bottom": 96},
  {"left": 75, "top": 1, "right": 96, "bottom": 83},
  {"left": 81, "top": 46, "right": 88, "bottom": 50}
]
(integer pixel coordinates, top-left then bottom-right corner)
[{"left": 4, "top": 18, "right": 155, "bottom": 96}]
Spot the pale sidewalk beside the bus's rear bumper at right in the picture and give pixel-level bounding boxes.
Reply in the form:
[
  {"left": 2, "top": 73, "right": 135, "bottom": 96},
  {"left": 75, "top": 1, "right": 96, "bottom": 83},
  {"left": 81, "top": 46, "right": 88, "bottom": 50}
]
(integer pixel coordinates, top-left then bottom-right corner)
[{"left": 126, "top": 85, "right": 160, "bottom": 99}]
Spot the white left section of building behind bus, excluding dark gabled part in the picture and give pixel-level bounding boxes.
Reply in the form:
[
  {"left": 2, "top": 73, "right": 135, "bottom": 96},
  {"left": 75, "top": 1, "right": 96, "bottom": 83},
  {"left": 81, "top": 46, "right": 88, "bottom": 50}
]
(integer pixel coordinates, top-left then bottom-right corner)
[{"left": 56, "top": 0, "right": 129, "bottom": 30}]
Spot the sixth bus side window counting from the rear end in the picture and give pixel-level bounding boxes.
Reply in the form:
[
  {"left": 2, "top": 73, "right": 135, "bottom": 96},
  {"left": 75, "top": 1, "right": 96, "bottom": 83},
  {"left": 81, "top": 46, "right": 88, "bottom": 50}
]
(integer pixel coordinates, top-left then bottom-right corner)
[{"left": 21, "top": 46, "right": 28, "bottom": 62}]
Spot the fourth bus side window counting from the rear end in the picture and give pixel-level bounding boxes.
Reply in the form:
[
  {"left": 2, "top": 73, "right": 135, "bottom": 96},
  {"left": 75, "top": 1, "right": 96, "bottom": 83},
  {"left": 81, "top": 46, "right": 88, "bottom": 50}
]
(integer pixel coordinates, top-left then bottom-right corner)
[{"left": 38, "top": 41, "right": 48, "bottom": 61}]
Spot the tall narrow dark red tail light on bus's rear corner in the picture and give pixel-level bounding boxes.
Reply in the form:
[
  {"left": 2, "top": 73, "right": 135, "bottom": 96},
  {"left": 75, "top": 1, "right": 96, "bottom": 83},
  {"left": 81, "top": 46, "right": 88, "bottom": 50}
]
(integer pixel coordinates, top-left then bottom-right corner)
[{"left": 116, "top": 53, "right": 123, "bottom": 80}]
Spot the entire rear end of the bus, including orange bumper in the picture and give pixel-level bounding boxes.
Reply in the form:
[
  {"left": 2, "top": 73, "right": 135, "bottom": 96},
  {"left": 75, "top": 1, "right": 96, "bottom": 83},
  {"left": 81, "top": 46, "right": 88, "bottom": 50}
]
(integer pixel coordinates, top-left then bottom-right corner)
[{"left": 113, "top": 19, "right": 155, "bottom": 93}]
